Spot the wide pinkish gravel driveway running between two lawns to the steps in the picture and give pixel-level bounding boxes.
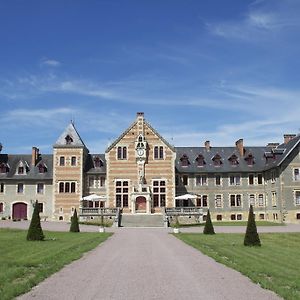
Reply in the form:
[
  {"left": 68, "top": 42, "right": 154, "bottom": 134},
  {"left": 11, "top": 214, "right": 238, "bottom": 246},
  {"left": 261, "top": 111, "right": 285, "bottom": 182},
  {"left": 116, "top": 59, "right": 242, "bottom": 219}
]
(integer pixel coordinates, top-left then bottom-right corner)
[{"left": 14, "top": 228, "right": 280, "bottom": 300}]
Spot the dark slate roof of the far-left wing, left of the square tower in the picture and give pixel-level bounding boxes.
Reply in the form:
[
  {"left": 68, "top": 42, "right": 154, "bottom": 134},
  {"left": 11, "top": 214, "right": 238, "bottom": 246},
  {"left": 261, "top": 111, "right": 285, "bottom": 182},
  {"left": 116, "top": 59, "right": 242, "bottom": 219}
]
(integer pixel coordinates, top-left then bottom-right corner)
[{"left": 0, "top": 154, "right": 53, "bottom": 181}]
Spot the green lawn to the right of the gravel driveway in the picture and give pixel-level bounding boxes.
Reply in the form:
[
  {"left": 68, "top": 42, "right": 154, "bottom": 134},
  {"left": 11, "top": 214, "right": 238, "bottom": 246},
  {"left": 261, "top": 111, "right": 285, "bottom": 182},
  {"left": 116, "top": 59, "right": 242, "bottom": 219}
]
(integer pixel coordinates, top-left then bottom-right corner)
[{"left": 175, "top": 233, "right": 300, "bottom": 300}]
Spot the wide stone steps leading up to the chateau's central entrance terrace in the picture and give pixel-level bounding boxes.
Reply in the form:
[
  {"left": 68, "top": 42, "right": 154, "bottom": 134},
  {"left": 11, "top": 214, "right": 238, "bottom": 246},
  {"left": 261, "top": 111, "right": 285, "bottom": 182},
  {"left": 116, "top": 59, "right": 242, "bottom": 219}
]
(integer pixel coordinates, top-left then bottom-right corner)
[{"left": 121, "top": 214, "right": 164, "bottom": 227}]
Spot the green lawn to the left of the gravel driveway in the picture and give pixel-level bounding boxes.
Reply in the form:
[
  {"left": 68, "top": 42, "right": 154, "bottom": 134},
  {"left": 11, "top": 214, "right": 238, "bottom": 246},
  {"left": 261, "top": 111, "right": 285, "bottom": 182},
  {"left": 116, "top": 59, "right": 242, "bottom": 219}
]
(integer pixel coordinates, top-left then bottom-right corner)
[{"left": 0, "top": 229, "right": 111, "bottom": 300}]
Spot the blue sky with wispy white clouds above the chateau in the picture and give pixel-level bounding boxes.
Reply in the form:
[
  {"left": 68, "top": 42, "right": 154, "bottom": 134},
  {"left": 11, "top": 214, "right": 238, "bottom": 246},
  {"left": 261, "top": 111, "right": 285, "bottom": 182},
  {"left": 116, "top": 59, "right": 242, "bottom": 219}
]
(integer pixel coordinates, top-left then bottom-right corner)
[{"left": 0, "top": 0, "right": 300, "bottom": 153}]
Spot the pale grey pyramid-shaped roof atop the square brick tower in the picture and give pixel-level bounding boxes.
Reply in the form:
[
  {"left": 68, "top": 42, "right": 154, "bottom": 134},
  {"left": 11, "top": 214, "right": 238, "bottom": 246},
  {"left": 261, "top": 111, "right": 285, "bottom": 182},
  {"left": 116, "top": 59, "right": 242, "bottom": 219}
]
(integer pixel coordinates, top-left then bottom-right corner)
[{"left": 53, "top": 122, "right": 86, "bottom": 148}]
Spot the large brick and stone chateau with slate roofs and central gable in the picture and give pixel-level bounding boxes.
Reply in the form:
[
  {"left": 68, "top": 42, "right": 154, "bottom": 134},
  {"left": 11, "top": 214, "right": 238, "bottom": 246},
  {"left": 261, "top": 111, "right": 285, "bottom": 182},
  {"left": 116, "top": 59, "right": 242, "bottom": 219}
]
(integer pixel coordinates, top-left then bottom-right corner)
[{"left": 0, "top": 113, "right": 300, "bottom": 223}]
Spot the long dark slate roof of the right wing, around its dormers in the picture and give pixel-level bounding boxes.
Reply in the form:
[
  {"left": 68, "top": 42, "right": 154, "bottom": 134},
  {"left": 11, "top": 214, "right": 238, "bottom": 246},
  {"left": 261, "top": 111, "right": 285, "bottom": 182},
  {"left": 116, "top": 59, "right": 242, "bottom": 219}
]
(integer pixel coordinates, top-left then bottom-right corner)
[{"left": 175, "top": 135, "right": 300, "bottom": 173}]
